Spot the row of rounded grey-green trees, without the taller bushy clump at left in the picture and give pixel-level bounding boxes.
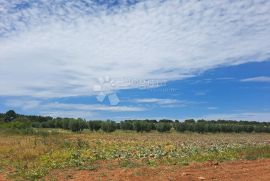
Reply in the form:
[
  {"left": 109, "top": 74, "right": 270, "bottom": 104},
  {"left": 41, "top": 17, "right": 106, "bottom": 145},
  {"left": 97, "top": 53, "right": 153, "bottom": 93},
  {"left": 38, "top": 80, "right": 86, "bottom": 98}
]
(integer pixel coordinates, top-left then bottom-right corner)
[{"left": 32, "top": 118, "right": 270, "bottom": 133}]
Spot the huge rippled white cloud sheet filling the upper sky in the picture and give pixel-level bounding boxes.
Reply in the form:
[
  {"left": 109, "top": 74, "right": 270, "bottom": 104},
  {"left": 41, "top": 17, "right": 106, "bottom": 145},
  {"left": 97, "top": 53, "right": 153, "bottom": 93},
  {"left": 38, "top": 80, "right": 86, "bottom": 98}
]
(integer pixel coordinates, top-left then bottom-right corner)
[{"left": 0, "top": 0, "right": 270, "bottom": 97}]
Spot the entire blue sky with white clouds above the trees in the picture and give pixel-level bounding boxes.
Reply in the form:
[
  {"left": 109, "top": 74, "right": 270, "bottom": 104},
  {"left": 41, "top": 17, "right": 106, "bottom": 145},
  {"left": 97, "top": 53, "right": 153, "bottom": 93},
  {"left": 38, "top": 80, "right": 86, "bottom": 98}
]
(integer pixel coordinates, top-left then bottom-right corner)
[{"left": 0, "top": 0, "right": 270, "bottom": 121}]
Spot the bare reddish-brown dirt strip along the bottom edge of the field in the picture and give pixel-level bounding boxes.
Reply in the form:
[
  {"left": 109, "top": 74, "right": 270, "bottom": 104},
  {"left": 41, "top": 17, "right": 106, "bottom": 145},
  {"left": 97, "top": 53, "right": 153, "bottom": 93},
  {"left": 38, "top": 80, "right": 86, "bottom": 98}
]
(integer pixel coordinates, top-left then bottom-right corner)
[{"left": 0, "top": 159, "right": 270, "bottom": 181}]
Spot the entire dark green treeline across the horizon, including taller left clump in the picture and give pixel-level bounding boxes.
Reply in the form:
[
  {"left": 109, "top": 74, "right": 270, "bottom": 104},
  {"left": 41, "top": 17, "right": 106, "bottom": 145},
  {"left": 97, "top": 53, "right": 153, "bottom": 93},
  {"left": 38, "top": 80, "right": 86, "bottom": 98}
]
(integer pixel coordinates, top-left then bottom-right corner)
[{"left": 0, "top": 110, "right": 270, "bottom": 133}]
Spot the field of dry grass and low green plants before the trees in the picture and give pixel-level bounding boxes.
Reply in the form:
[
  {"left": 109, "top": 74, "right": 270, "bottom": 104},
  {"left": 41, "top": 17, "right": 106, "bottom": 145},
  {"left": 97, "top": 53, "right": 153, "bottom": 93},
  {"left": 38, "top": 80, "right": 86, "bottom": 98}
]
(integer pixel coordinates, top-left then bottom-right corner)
[{"left": 0, "top": 129, "right": 270, "bottom": 180}]
